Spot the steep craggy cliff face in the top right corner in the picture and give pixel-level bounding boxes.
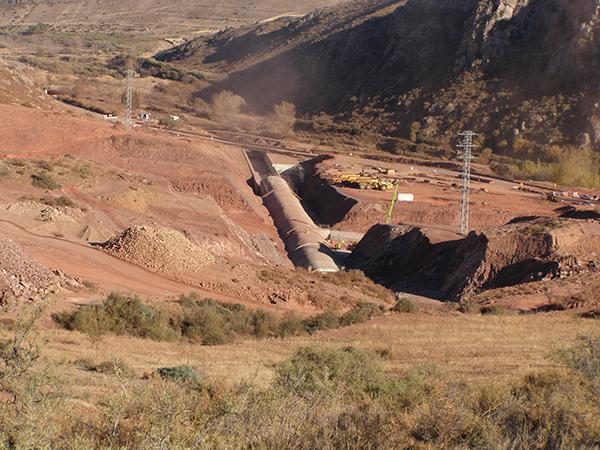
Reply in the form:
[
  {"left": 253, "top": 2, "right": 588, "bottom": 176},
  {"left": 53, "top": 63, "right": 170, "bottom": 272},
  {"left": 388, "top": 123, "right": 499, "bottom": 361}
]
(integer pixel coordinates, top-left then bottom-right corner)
[{"left": 465, "top": 0, "right": 600, "bottom": 80}]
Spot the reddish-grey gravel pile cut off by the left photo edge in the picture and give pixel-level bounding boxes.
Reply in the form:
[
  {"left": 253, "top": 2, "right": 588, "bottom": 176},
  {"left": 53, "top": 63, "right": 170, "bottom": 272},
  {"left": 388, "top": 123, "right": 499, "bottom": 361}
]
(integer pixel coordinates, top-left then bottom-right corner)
[{"left": 0, "top": 237, "right": 60, "bottom": 304}]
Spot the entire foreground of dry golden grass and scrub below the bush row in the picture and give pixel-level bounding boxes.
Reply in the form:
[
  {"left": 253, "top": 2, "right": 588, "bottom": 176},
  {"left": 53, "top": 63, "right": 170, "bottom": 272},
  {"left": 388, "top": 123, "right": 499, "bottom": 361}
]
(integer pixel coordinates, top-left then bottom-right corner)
[{"left": 0, "top": 298, "right": 600, "bottom": 449}]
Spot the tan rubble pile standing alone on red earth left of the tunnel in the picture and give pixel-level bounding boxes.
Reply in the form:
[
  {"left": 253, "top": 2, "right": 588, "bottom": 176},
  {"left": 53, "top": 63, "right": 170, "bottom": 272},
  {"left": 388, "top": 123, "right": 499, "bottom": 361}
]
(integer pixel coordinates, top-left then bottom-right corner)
[{"left": 100, "top": 225, "right": 215, "bottom": 273}]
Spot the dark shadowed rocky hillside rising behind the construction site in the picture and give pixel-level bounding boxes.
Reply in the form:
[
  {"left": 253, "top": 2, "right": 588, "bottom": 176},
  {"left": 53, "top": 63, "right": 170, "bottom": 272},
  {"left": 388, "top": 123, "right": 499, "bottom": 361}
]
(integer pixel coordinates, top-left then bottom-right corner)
[{"left": 158, "top": 0, "right": 600, "bottom": 159}]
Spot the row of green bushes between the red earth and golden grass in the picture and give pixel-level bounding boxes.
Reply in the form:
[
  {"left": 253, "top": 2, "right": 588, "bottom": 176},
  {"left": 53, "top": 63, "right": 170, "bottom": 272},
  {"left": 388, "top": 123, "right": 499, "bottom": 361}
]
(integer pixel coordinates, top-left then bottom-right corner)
[{"left": 53, "top": 293, "right": 384, "bottom": 345}]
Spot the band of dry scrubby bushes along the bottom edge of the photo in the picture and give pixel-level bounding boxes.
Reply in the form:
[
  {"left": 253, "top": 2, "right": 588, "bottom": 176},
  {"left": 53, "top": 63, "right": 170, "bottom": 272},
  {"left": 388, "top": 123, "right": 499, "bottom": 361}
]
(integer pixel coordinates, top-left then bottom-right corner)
[{"left": 0, "top": 334, "right": 600, "bottom": 449}]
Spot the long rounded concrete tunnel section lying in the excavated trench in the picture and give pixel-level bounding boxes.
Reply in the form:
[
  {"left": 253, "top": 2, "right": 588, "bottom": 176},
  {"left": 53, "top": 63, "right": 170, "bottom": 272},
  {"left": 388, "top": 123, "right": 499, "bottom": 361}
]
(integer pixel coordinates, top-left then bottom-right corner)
[{"left": 244, "top": 150, "right": 339, "bottom": 272}]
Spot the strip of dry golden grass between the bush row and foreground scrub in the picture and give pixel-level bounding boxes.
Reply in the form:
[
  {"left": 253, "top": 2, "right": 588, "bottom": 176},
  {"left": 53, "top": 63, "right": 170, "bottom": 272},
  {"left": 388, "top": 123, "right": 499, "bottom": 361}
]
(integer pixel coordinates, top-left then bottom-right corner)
[{"left": 38, "top": 313, "right": 598, "bottom": 396}]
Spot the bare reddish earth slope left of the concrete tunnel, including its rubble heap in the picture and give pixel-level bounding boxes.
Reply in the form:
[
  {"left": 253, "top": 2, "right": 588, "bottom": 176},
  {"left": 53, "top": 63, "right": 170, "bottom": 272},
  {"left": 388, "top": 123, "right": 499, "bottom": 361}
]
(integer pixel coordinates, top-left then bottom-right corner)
[{"left": 0, "top": 101, "right": 392, "bottom": 312}]
